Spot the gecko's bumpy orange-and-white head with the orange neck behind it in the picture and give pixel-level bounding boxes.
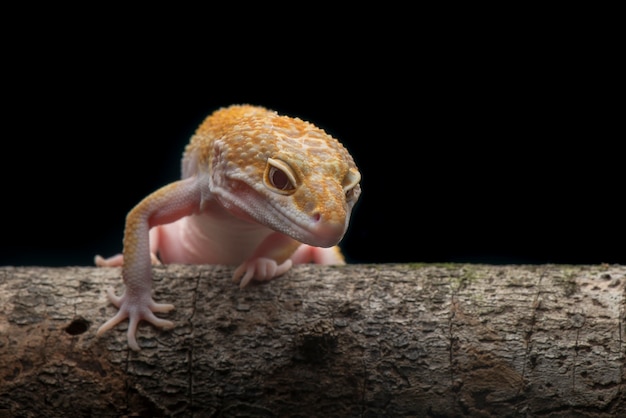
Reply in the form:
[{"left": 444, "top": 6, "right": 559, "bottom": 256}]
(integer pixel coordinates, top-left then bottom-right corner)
[{"left": 183, "top": 105, "right": 361, "bottom": 247}]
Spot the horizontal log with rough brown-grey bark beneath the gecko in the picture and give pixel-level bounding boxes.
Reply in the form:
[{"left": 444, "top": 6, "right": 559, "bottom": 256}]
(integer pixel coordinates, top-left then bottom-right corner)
[{"left": 0, "top": 264, "right": 626, "bottom": 417}]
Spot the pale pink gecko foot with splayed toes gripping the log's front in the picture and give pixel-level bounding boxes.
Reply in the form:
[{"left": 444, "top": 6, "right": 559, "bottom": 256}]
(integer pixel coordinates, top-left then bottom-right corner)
[{"left": 96, "top": 289, "right": 174, "bottom": 351}]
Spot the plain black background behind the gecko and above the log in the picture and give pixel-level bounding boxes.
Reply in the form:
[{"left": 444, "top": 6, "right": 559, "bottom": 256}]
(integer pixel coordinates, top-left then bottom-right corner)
[{"left": 0, "top": 10, "right": 626, "bottom": 266}]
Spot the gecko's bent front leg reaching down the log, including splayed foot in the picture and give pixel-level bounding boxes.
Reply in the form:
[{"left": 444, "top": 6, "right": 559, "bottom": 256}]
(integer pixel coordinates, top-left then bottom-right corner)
[{"left": 97, "top": 177, "right": 201, "bottom": 350}]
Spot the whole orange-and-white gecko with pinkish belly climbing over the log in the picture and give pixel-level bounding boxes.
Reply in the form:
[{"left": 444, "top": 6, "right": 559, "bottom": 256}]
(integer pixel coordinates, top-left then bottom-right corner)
[{"left": 94, "top": 104, "right": 361, "bottom": 351}]
